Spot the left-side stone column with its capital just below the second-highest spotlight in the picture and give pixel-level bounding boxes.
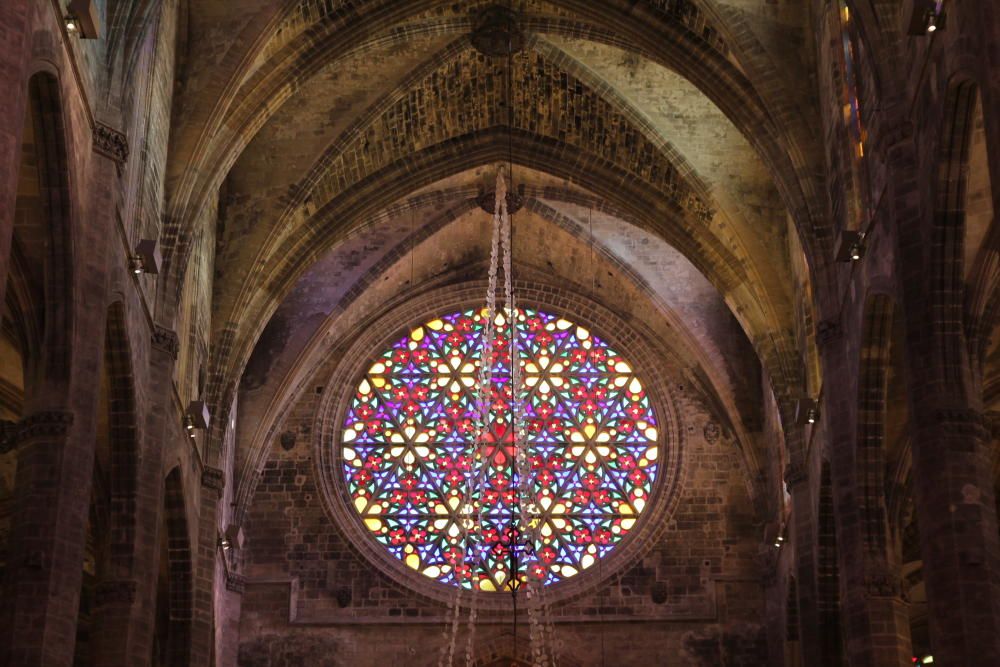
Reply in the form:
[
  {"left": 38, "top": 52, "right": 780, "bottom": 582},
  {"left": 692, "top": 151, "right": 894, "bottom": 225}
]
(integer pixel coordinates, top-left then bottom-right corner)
[{"left": 94, "top": 326, "right": 183, "bottom": 667}]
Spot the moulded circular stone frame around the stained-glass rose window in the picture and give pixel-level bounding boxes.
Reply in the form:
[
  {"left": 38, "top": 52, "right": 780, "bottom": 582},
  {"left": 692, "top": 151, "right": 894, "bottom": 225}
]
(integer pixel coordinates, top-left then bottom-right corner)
[{"left": 313, "top": 282, "right": 684, "bottom": 609}]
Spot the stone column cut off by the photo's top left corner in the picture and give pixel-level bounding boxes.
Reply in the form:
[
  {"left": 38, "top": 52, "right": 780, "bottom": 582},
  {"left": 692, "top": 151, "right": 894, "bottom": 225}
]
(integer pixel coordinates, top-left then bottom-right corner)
[{"left": 0, "top": 0, "right": 31, "bottom": 304}]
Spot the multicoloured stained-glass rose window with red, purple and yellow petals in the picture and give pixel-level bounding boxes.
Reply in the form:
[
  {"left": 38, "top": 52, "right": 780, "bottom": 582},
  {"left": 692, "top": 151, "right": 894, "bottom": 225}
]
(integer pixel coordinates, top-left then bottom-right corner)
[{"left": 338, "top": 309, "right": 662, "bottom": 591}]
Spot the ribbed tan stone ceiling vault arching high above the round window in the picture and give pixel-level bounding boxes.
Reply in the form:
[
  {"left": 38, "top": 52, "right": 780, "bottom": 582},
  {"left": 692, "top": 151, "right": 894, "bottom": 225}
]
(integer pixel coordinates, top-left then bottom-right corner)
[{"left": 156, "top": 0, "right": 830, "bottom": 516}]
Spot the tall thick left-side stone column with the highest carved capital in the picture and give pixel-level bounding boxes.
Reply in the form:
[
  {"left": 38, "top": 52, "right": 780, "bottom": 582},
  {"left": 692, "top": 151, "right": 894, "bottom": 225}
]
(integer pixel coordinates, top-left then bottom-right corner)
[{"left": 0, "top": 128, "right": 115, "bottom": 667}]
